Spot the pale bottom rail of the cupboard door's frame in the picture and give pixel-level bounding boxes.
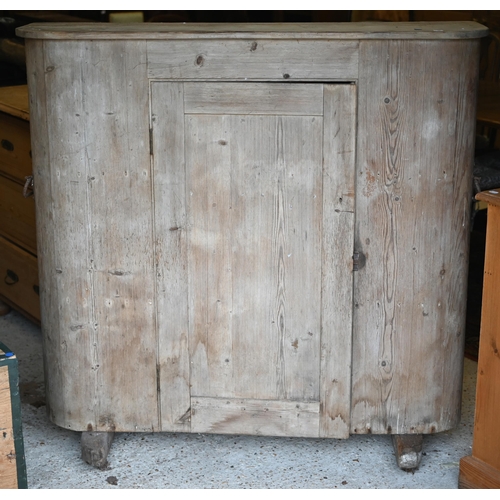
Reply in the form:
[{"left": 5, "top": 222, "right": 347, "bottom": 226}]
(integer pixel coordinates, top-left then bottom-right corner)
[{"left": 191, "top": 397, "right": 319, "bottom": 437}]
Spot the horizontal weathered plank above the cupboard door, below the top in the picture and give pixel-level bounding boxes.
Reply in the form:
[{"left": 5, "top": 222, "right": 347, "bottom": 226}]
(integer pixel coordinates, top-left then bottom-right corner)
[{"left": 147, "top": 40, "right": 358, "bottom": 81}]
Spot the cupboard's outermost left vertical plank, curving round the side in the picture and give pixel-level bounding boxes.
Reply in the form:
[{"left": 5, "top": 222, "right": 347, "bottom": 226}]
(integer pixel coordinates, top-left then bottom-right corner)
[{"left": 27, "top": 41, "right": 96, "bottom": 430}]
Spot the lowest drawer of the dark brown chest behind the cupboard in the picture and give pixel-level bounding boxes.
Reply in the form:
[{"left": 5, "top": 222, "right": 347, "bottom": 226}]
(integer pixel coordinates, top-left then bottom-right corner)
[{"left": 0, "top": 236, "right": 40, "bottom": 321}]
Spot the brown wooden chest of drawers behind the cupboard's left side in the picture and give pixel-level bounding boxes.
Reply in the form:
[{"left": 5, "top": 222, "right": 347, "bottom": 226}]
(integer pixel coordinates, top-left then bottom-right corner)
[{"left": 0, "top": 85, "right": 40, "bottom": 323}]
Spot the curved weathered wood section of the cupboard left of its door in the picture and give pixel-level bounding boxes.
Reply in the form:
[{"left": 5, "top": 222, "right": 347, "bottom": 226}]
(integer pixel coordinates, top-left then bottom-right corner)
[{"left": 28, "top": 42, "right": 158, "bottom": 431}]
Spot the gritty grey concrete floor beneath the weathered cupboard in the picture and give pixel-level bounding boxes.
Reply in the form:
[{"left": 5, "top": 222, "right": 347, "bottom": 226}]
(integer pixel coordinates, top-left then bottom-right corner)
[{"left": 0, "top": 311, "right": 477, "bottom": 489}]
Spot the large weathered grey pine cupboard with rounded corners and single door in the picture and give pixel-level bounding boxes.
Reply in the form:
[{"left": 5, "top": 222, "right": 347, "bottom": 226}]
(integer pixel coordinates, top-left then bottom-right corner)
[{"left": 18, "top": 22, "right": 487, "bottom": 467}]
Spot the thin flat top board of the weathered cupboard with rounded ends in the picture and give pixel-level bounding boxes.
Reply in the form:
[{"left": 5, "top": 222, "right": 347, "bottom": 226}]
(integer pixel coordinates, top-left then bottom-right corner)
[{"left": 16, "top": 21, "right": 488, "bottom": 40}]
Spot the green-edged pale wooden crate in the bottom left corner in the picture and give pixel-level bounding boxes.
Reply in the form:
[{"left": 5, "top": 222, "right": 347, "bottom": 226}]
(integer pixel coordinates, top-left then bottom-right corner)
[{"left": 0, "top": 342, "right": 28, "bottom": 489}]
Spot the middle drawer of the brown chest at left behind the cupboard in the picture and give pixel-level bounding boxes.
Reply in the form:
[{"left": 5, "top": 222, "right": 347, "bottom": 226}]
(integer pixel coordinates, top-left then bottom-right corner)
[{"left": 0, "top": 175, "right": 36, "bottom": 254}]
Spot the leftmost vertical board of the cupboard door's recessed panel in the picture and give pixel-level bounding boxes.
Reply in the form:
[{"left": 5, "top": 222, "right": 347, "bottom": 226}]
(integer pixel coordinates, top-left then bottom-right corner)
[{"left": 186, "top": 115, "right": 234, "bottom": 397}]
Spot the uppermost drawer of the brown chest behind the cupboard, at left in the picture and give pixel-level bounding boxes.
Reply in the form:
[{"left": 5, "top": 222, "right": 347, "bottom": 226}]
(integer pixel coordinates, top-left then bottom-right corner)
[{"left": 0, "top": 113, "right": 31, "bottom": 183}]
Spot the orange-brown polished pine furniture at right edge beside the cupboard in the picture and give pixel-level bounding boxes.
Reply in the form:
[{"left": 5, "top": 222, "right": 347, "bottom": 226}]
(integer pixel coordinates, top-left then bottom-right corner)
[{"left": 459, "top": 190, "right": 500, "bottom": 488}]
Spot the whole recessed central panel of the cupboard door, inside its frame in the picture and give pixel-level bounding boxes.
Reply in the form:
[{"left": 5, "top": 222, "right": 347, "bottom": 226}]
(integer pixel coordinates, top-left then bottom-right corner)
[{"left": 186, "top": 108, "right": 322, "bottom": 400}]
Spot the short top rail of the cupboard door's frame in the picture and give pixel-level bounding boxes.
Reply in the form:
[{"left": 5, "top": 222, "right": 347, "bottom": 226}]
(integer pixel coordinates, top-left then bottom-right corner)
[{"left": 184, "top": 82, "right": 323, "bottom": 116}]
